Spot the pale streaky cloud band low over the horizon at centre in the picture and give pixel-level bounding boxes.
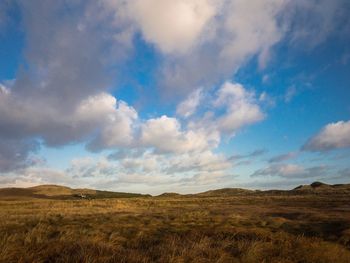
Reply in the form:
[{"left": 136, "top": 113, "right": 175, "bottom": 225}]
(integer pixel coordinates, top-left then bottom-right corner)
[{"left": 66, "top": 150, "right": 232, "bottom": 186}]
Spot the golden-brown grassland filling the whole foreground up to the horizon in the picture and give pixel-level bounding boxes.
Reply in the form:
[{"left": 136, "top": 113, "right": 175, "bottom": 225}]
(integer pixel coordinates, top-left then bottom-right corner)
[{"left": 0, "top": 186, "right": 350, "bottom": 263}]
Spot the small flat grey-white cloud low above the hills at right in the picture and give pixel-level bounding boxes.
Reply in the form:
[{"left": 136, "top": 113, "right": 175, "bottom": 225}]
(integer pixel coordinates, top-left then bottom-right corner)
[{"left": 250, "top": 164, "right": 328, "bottom": 179}]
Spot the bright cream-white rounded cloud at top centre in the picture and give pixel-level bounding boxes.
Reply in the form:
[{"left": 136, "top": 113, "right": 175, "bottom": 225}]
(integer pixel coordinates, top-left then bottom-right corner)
[{"left": 129, "top": 0, "right": 216, "bottom": 53}]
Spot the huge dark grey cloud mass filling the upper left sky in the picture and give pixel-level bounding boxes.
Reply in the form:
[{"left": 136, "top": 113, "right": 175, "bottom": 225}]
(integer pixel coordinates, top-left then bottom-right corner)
[{"left": 0, "top": 0, "right": 135, "bottom": 172}]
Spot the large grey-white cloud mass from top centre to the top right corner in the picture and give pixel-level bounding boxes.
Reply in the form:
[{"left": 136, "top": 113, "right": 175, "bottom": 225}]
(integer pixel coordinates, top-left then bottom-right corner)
[{"left": 130, "top": 0, "right": 349, "bottom": 95}]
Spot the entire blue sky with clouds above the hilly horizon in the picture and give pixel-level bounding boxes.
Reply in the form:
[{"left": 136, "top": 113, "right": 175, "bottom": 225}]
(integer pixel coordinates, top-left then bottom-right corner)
[{"left": 0, "top": 0, "right": 350, "bottom": 194}]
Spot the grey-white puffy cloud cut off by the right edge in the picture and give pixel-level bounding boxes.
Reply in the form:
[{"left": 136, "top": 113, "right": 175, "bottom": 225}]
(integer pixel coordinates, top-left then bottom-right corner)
[{"left": 302, "top": 121, "right": 350, "bottom": 152}]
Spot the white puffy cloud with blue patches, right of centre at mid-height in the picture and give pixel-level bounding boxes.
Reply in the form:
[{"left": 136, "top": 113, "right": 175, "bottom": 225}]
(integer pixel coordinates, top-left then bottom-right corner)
[{"left": 182, "top": 82, "right": 265, "bottom": 142}]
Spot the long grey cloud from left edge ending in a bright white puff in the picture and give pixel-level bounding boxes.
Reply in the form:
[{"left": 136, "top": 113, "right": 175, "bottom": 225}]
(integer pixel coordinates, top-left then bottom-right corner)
[{"left": 0, "top": 89, "right": 137, "bottom": 147}]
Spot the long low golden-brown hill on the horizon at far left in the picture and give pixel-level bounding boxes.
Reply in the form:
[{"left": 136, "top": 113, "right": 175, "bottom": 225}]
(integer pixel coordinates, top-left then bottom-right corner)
[{"left": 0, "top": 185, "right": 150, "bottom": 199}]
